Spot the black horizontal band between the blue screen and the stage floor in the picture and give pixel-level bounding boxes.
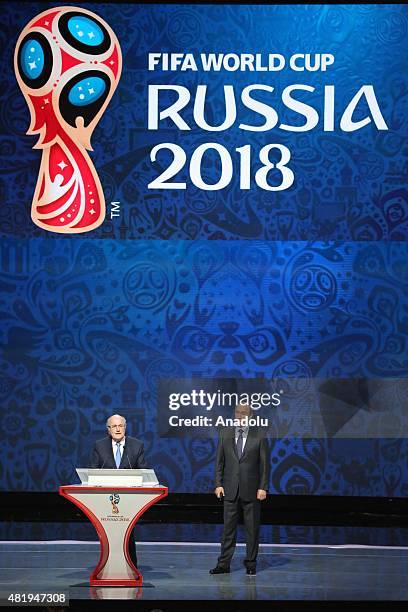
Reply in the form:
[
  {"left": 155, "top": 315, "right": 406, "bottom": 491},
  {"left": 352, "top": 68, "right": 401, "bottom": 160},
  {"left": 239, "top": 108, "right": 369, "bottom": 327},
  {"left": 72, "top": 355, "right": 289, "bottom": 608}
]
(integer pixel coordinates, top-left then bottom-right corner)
[{"left": 0, "top": 491, "right": 408, "bottom": 527}]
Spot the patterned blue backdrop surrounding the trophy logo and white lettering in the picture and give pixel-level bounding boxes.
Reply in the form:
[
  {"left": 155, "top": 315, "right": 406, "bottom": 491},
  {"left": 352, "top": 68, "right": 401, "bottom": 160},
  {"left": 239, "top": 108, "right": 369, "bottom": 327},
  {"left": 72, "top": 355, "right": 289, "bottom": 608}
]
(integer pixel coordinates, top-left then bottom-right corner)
[{"left": 0, "top": 2, "right": 408, "bottom": 494}]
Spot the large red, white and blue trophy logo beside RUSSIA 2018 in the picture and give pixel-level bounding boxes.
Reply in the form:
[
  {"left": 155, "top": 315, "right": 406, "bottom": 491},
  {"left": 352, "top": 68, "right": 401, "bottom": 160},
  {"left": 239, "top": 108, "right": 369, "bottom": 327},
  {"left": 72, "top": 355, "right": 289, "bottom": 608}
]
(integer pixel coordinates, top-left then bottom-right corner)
[{"left": 14, "top": 6, "right": 122, "bottom": 234}]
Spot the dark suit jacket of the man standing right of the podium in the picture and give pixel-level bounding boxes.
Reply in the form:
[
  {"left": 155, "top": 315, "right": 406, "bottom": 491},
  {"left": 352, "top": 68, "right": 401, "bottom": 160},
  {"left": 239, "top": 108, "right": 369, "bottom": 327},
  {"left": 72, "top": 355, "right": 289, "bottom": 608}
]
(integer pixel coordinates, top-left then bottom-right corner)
[{"left": 215, "top": 427, "right": 269, "bottom": 501}]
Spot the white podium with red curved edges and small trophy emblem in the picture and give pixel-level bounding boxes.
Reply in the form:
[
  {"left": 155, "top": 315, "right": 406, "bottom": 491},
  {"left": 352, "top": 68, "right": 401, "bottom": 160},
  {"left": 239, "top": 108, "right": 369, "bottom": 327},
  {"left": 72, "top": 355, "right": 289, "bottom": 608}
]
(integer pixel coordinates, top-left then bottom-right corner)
[{"left": 59, "top": 470, "right": 168, "bottom": 587}]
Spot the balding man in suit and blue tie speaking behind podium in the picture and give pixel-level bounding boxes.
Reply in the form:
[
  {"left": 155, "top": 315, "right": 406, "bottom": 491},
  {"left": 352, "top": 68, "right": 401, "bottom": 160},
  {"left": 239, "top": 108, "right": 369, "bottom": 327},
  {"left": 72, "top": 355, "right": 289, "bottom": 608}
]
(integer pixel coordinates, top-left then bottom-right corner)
[{"left": 89, "top": 414, "right": 147, "bottom": 567}]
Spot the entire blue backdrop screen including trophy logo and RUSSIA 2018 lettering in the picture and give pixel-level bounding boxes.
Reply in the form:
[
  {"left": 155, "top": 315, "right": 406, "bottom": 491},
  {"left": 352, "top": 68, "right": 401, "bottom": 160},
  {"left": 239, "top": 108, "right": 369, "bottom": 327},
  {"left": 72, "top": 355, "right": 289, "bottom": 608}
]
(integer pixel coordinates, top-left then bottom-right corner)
[{"left": 0, "top": 2, "right": 408, "bottom": 496}]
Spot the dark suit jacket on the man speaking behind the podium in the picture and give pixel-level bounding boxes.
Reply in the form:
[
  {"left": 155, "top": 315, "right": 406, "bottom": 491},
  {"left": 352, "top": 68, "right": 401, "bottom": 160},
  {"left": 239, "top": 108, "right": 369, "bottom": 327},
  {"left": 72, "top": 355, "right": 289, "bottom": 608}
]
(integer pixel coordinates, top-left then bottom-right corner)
[{"left": 89, "top": 436, "right": 147, "bottom": 470}]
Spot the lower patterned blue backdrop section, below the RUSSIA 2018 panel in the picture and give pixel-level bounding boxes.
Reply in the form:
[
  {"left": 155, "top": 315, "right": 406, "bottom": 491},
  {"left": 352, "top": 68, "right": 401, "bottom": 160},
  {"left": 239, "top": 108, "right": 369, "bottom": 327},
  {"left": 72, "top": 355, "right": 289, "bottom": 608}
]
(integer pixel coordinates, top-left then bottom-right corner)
[{"left": 0, "top": 238, "right": 408, "bottom": 496}]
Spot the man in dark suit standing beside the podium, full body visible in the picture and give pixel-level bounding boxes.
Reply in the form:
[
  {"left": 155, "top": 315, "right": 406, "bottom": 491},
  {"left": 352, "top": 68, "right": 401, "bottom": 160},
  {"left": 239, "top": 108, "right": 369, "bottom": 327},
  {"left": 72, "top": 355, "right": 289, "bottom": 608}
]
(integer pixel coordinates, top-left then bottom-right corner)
[{"left": 210, "top": 405, "right": 269, "bottom": 576}]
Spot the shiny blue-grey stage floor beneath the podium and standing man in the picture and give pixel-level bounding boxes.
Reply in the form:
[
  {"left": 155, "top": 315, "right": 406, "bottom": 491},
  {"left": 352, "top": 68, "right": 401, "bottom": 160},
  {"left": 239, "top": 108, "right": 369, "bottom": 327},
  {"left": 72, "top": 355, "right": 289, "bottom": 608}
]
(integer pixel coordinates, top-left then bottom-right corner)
[{"left": 0, "top": 541, "right": 408, "bottom": 602}]
